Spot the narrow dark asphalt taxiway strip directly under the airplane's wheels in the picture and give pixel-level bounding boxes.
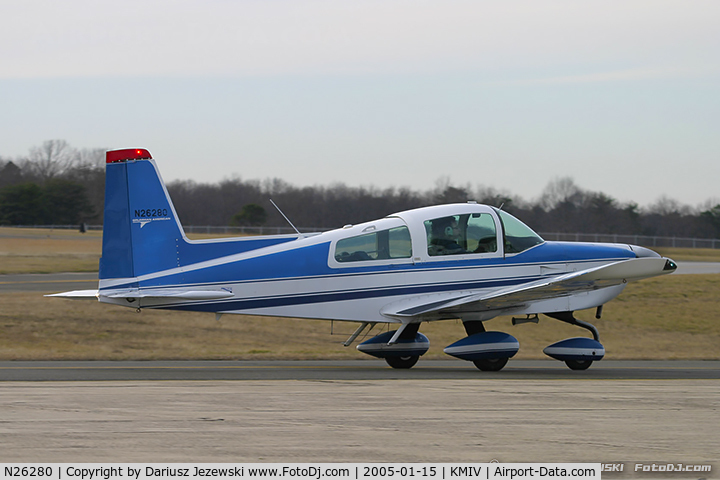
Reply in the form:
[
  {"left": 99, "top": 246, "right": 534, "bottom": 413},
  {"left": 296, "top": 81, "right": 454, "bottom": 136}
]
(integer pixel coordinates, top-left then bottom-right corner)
[{"left": 0, "top": 360, "right": 720, "bottom": 382}]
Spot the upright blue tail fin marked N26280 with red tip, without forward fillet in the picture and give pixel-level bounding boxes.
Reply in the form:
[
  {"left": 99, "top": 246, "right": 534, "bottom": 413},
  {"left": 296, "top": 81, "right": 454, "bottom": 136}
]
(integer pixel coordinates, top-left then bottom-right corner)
[{"left": 99, "top": 149, "right": 185, "bottom": 280}]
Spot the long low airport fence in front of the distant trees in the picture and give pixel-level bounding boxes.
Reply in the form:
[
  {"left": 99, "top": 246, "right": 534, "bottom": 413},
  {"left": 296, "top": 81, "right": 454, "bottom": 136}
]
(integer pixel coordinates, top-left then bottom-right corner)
[{"left": 5, "top": 225, "right": 720, "bottom": 249}]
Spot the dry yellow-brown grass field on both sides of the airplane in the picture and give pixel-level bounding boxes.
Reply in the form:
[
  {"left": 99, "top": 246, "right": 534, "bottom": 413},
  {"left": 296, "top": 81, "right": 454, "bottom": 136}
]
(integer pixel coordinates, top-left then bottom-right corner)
[{"left": 0, "top": 228, "right": 720, "bottom": 360}]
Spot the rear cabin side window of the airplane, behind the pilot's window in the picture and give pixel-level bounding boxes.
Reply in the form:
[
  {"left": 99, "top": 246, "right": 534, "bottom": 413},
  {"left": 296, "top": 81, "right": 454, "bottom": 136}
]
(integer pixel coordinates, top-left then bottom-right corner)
[{"left": 335, "top": 227, "right": 412, "bottom": 263}]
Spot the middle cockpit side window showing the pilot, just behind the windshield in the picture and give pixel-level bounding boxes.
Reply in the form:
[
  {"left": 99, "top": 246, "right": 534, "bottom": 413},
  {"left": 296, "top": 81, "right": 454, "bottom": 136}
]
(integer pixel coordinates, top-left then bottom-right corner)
[{"left": 425, "top": 213, "right": 497, "bottom": 257}]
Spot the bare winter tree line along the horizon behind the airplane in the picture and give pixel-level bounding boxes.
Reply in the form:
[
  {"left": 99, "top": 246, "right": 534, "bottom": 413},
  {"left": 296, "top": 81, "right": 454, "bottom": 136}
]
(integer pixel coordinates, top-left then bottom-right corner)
[{"left": 0, "top": 140, "right": 720, "bottom": 238}]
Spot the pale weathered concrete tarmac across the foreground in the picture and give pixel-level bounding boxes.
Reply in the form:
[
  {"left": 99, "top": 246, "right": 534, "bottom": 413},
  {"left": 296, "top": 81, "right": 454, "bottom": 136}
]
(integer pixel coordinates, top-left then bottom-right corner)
[{"left": 0, "top": 362, "right": 720, "bottom": 466}]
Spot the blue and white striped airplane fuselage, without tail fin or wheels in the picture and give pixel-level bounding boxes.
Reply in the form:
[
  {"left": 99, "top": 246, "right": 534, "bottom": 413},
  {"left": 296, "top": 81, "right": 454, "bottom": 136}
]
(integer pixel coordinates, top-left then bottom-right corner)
[{"left": 100, "top": 203, "right": 647, "bottom": 323}]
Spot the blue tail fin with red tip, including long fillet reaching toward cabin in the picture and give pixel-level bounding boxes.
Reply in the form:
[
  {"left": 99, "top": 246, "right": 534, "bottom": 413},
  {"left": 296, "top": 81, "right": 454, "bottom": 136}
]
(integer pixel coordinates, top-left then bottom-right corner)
[{"left": 99, "top": 149, "right": 298, "bottom": 289}]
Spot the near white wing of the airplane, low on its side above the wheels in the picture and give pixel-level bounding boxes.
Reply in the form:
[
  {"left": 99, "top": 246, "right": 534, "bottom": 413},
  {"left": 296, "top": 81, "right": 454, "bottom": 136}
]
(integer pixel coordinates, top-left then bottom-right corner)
[{"left": 382, "top": 258, "right": 676, "bottom": 321}]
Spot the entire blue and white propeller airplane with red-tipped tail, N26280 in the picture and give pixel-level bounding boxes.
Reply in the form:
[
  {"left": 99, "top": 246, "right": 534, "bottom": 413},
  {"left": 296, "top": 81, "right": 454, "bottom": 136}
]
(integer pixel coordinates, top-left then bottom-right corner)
[{"left": 52, "top": 149, "right": 677, "bottom": 371}]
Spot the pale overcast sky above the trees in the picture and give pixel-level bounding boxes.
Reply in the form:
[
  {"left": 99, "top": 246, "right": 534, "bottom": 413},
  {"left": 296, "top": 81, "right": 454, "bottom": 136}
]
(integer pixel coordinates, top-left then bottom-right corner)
[{"left": 0, "top": 0, "right": 720, "bottom": 206}]
